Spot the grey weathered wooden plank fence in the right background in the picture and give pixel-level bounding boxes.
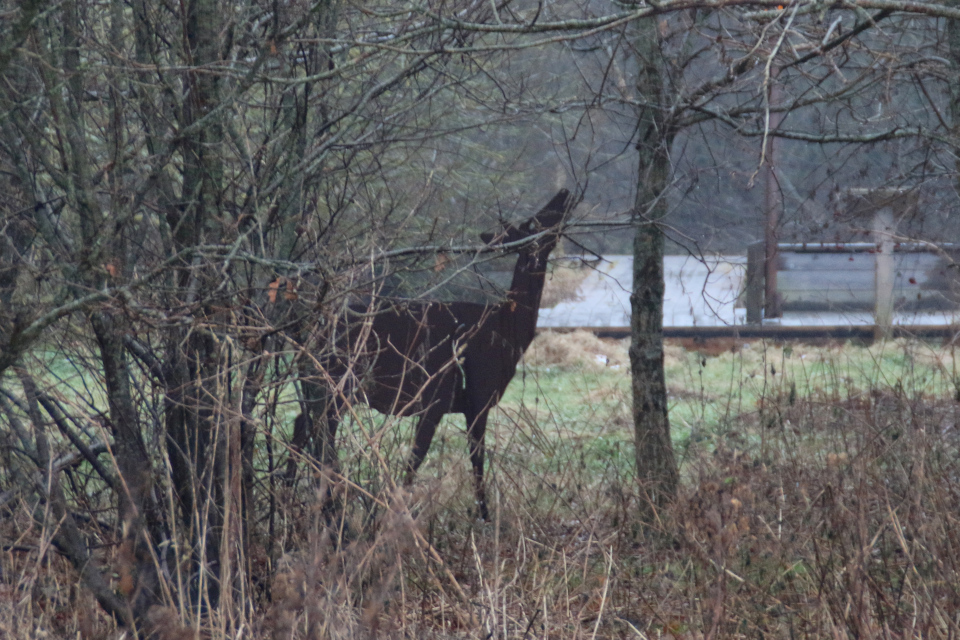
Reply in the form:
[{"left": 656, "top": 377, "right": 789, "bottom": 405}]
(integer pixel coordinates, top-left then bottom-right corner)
[{"left": 746, "top": 242, "right": 960, "bottom": 325}]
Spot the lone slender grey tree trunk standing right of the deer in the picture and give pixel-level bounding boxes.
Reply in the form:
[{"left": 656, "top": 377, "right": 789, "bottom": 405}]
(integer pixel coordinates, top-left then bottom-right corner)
[{"left": 630, "top": 13, "right": 679, "bottom": 522}]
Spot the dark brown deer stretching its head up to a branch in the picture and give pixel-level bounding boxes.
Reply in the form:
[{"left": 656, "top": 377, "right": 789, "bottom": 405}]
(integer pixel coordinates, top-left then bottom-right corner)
[{"left": 312, "top": 189, "right": 572, "bottom": 520}]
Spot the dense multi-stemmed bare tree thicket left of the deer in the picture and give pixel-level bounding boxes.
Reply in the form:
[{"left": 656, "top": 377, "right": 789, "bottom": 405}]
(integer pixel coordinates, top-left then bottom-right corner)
[{"left": 0, "top": 0, "right": 548, "bottom": 628}]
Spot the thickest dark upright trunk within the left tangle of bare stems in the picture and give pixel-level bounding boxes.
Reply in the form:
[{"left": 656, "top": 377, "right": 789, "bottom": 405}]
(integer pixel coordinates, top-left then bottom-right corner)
[{"left": 165, "top": 0, "right": 235, "bottom": 607}]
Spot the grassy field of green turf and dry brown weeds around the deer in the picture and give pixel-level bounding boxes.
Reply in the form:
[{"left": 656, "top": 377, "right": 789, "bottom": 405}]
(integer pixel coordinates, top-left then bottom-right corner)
[{"left": 0, "top": 334, "right": 960, "bottom": 640}]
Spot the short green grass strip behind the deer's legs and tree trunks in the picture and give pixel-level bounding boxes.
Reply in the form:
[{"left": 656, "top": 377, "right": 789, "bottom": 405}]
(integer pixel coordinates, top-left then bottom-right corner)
[{"left": 20, "top": 334, "right": 958, "bottom": 488}]
